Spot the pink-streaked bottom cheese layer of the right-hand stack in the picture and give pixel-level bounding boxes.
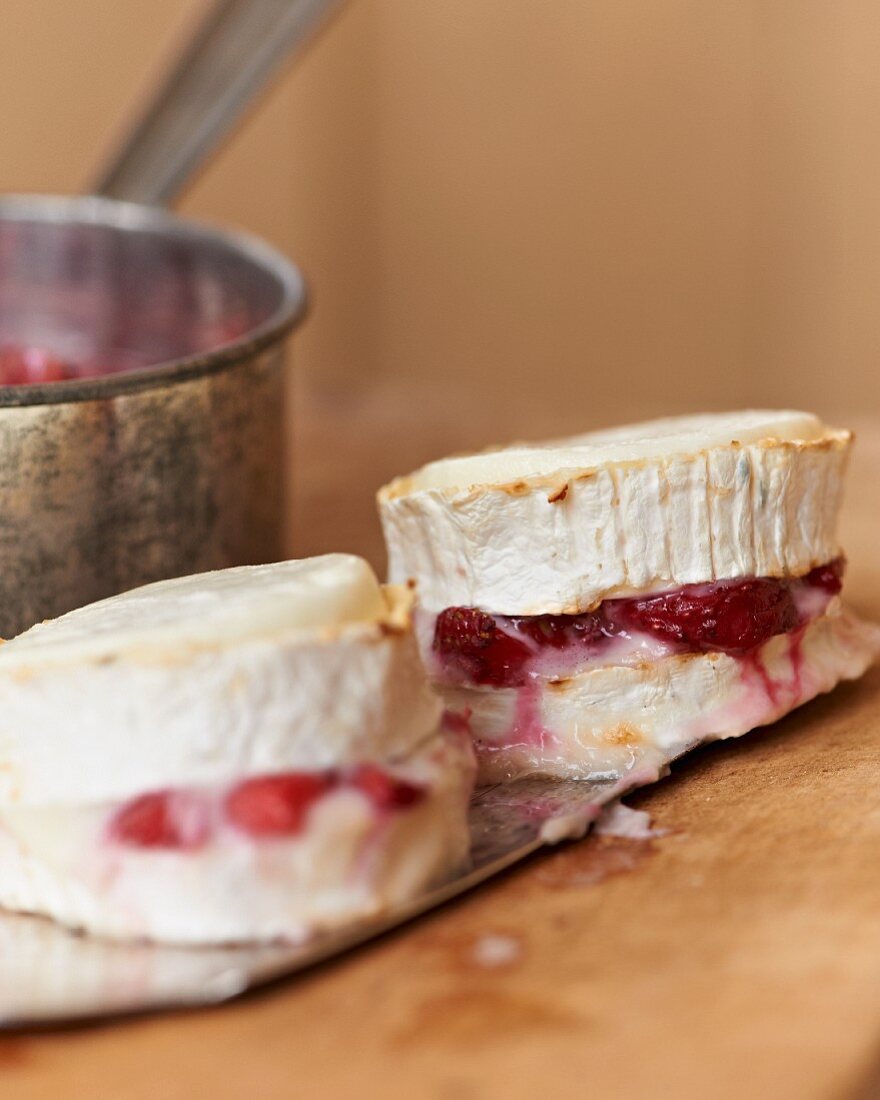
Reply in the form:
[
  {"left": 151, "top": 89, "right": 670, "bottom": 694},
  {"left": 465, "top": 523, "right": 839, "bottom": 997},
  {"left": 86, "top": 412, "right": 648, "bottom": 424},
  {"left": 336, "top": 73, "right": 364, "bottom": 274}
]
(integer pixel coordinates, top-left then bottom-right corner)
[{"left": 437, "top": 601, "right": 880, "bottom": 782}]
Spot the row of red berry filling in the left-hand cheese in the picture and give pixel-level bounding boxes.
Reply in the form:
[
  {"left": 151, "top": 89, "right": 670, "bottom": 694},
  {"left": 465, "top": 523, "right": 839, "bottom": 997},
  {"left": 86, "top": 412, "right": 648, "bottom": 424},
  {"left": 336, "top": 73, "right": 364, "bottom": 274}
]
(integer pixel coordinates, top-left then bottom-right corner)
[{"left": 108, "top": 763, "right": 427, "bottom": 851}]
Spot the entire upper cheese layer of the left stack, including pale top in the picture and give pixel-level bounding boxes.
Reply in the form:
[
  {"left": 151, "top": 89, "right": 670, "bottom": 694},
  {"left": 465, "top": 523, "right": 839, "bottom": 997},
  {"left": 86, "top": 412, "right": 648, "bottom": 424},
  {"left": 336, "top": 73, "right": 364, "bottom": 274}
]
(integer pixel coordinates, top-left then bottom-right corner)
[{"left": 0, "top": 556, "right": 440, "bottom": 805}]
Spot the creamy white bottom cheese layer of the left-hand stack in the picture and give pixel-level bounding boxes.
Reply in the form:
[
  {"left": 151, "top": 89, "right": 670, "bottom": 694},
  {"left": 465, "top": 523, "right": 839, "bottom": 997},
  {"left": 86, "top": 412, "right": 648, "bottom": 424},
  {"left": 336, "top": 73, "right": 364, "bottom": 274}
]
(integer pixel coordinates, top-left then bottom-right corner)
[{"left": 0, "top": 732, "right": 474, "bottom": 944}]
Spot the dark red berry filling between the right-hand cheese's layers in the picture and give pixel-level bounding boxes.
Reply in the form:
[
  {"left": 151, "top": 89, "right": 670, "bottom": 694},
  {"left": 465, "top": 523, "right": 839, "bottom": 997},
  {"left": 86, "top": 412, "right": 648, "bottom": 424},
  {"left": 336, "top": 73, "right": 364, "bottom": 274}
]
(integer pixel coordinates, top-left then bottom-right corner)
[{"left": 432, "top": 558, "right": 844, "bottom": 688}]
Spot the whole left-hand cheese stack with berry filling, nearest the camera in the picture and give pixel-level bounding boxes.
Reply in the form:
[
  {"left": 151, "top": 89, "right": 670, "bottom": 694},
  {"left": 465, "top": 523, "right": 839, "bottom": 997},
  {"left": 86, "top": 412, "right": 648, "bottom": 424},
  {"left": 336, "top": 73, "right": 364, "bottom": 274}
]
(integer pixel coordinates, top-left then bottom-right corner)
[{"left": 0, "top": 554, "right": 474, "bottom": 944}]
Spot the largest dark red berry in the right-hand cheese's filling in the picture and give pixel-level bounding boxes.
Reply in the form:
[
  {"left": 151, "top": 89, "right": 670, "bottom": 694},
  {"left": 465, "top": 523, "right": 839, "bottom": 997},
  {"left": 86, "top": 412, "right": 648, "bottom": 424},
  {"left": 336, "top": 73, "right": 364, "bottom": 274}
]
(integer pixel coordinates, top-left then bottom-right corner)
[{"left": 612, "top": 578, "right": 798, "bottom": 653}]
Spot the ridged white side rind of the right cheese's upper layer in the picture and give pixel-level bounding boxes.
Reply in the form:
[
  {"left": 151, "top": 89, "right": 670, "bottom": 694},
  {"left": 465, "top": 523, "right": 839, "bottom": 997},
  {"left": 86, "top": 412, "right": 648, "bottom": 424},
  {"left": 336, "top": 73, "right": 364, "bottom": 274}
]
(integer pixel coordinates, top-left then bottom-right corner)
[{"left": 378, "top": 418, "right": 850, "bottom": 615}]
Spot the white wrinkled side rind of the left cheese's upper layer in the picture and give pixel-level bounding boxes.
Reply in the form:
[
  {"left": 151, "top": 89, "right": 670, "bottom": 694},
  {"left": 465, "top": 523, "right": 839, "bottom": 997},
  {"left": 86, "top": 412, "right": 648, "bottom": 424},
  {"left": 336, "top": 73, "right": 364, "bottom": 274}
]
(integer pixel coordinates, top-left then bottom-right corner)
[{"left": 0, "top": 598, "right": 440, "bottom": 804}]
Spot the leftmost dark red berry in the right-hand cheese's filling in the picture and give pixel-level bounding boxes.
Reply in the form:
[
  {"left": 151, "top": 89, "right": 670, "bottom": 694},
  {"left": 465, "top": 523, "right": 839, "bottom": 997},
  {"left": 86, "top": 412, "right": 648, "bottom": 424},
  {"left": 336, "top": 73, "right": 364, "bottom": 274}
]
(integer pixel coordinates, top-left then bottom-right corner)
[{"left": 433, "top": 607, "right": 532, "bottom": 688}]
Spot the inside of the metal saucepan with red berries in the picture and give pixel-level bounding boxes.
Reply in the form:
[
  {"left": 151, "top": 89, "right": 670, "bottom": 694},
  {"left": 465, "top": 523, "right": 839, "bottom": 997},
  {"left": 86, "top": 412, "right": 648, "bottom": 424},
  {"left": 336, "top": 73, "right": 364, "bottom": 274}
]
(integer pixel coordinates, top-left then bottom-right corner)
[{"left": 0, "top": 218, "right": 281, "bottom": 386}]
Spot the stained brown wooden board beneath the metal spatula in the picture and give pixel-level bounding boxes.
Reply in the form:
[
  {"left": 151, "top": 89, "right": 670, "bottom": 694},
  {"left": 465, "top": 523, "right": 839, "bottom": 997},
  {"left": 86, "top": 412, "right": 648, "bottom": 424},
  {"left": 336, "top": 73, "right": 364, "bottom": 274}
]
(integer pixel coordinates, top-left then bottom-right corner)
[{"left": 0, "top": 407, "right": 880, "bottom": 1100}]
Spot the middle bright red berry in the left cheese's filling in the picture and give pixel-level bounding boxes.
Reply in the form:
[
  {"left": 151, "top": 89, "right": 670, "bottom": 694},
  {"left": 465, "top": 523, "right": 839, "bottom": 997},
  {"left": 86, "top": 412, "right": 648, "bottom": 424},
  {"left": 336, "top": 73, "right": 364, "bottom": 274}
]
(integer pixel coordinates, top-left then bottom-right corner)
[{"left": 226, "top": 772, "right": 333, "bottom": 837}]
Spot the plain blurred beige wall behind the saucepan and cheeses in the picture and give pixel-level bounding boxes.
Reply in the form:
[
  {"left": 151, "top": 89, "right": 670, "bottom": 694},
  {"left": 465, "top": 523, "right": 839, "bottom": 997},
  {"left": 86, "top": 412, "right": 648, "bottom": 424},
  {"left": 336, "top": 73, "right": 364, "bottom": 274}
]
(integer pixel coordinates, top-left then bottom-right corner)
[{"left": 0, "top": 0, "right": 880, "bottom": 557}]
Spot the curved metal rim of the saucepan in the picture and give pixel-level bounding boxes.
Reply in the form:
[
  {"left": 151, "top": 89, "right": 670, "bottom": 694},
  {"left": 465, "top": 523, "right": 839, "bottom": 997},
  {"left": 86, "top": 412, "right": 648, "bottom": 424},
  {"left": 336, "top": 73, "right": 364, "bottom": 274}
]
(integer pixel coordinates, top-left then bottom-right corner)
[{"left": 0, "top": 195, "right": 307, "bottom": 409}]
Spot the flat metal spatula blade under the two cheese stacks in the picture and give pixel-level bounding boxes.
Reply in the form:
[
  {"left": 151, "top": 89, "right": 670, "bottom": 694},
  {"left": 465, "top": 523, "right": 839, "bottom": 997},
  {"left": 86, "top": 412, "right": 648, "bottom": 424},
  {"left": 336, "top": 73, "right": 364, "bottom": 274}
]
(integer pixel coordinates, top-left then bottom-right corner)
[{"left": 0, "top": 778, "right": 646, "bottom": 1030}]
